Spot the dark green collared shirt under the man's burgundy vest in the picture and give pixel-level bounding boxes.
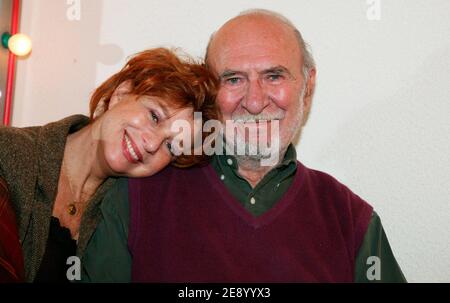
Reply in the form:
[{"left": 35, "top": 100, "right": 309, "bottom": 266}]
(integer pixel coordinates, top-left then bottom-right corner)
[{"left": 81, "top": 145, "right": 406, "bottom": 283}]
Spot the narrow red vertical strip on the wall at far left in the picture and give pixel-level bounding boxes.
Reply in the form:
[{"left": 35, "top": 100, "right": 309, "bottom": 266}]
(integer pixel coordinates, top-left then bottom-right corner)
[{"left": 3, "top": 0, "right": 20, "bottom": 125}]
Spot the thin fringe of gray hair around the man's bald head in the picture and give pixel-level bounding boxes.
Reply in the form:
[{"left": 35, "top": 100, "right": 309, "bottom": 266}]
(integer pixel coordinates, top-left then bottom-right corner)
[{"left": 205, "top": 9, "right": 316, "bottom": 81}]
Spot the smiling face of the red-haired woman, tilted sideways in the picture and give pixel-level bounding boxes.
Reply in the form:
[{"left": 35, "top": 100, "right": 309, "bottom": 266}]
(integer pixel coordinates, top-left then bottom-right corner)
[{"left": 97, "top": 94, "right": 193, "bottom": 177}]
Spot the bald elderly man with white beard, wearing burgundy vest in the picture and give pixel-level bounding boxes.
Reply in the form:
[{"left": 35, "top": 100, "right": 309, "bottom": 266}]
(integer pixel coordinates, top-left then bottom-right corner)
[{"left": 82, "top": 10, "right": 405, "bottom": 282}]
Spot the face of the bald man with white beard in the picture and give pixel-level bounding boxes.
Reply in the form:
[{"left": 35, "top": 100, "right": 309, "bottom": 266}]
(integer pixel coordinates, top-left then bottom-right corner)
[{"left": 208, "top": 17, "right": 304, "bottom": 162}]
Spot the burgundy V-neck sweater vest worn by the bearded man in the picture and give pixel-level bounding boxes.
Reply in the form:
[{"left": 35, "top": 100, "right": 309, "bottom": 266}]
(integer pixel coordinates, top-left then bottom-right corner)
[{"left": 128, "top": 163, "right": 372, "bottom": 282}]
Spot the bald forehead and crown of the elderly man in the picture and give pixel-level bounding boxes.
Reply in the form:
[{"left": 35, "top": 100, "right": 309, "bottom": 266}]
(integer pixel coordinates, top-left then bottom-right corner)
[{"left": 208, "top": 16, "right": 302, "bottom": 78}]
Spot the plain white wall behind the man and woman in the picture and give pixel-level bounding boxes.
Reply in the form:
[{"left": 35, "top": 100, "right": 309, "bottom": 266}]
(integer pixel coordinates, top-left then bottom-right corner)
[{"left": 13, "top": 0, "right": 450, "bottom": 282}]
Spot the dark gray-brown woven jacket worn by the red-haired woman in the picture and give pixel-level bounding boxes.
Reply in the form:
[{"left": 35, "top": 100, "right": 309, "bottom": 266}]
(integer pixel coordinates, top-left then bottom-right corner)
[{"left": 0, "top": 115, "right": 116, "bottom": 282}]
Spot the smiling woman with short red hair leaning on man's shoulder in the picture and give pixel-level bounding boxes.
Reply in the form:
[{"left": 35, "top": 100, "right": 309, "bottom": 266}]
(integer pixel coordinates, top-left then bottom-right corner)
[{"left": 0, "top": 48, "right": 217, "bottom": 282}]
